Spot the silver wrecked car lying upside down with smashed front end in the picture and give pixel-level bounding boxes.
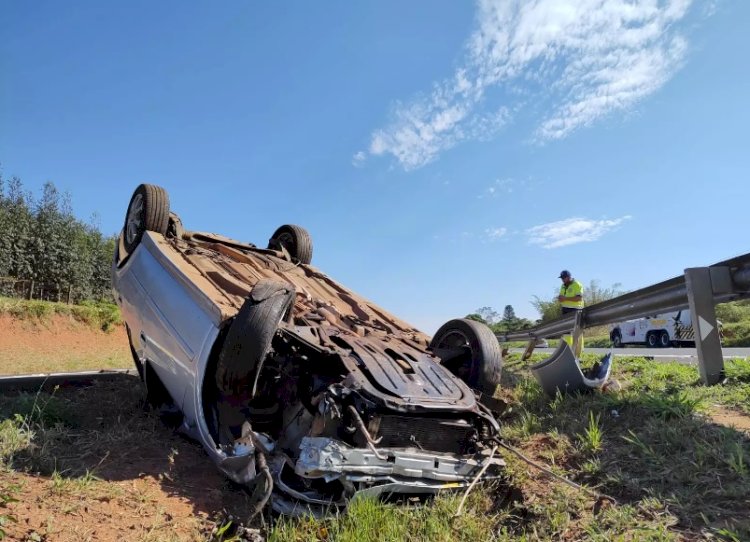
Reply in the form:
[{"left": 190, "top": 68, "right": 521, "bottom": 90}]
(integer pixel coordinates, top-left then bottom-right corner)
[{"left": 113, "top": 184, "right": 503, "bottom": 514}]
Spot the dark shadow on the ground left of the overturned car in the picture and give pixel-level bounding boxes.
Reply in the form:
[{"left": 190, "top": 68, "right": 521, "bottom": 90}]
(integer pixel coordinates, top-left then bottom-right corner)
[{"left": 0, "top": 376, "right": 254, "bottom": 528}]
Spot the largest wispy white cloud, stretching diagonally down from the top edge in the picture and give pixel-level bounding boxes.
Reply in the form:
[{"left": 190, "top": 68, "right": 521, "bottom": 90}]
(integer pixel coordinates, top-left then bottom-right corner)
[{"left": 368, "top": 0, "right": 691, "bottom": 170}]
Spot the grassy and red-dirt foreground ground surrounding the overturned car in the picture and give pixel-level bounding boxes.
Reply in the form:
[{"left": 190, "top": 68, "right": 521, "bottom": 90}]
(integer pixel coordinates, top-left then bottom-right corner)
[{"left": 0, "top": 355, "right": 750, "bottom": 542}]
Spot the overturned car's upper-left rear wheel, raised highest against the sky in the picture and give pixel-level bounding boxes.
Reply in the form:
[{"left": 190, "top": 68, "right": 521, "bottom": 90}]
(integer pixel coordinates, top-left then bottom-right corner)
[{"left": 123, "top": 184, "right": 169, "bottom": 253}]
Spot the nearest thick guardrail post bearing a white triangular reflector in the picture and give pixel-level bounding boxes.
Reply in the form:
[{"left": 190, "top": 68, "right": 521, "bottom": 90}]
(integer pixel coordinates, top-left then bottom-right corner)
[{"left": 685, "top": 267, "right": 724, "bottom": 385}]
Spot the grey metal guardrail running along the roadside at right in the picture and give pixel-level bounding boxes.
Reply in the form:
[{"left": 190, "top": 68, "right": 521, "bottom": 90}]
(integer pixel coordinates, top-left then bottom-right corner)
[{"left": 497, "top": 254, "right": 750, "bottom": 384}]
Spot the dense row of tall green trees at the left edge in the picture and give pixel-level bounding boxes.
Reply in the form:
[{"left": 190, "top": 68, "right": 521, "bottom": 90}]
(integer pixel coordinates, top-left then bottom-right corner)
[{"left": 0, "top": 174, "right": 115, "bottom": 302}]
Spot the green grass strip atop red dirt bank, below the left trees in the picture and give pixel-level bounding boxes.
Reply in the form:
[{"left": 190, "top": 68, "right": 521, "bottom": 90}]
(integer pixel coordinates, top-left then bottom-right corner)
[{"left": 0, "top": 297, "right": 122, "bottom": 331}]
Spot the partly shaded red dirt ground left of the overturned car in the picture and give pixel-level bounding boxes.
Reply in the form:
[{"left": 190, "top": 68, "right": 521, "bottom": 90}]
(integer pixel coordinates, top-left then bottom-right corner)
[{"left": 0, "top": 376, "right": 250, "bottom": 542}]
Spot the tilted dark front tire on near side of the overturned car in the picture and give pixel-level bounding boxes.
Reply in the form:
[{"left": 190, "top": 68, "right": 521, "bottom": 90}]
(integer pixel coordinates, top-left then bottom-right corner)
[{"left": 216, "top": 279, "right": 295, "bottom": 396}]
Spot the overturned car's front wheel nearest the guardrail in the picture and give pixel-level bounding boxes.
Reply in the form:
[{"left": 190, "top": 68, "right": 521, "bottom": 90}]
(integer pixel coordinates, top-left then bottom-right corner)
[{"left": 430, "top": 318, "right": 503, "bottom": 396}]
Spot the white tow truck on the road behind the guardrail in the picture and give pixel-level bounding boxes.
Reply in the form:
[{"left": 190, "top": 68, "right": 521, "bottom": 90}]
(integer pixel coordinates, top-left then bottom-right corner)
[{"left": 609, "top": 310, "right": 712, "bottom": 348}]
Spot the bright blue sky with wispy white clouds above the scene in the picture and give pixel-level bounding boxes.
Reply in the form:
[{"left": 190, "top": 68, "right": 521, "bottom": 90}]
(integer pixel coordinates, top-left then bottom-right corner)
[{"left": 0, "top": 0, "right": 750, "bottom": 334}]
